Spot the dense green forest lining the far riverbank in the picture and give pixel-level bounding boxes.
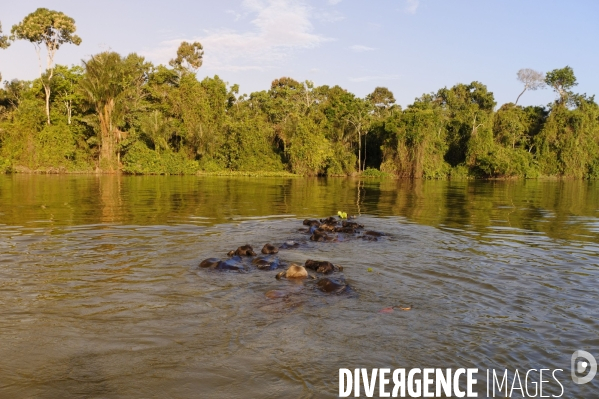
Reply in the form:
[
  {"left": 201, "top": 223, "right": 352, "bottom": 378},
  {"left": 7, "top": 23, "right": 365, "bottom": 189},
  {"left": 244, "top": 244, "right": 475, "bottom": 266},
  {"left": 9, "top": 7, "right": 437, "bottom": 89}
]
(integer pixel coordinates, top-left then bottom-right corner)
[{"left": 0, "top": 8, "right": 599, "bottom": 179}]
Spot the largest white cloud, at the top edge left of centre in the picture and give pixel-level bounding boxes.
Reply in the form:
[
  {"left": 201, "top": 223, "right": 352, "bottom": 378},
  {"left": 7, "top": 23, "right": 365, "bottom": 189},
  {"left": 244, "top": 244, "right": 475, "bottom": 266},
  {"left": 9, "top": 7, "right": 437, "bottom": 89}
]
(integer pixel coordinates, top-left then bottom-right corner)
[{"left": 143, "top": 0, "right": 332, "bottom": 71}]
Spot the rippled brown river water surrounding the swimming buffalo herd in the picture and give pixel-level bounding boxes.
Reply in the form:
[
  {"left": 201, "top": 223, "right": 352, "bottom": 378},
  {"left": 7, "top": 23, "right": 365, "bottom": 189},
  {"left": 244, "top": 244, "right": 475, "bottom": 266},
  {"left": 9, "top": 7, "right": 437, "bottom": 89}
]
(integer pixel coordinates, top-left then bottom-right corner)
[{"left": 0, "top": 175, "right": 599, "bottom": 398}]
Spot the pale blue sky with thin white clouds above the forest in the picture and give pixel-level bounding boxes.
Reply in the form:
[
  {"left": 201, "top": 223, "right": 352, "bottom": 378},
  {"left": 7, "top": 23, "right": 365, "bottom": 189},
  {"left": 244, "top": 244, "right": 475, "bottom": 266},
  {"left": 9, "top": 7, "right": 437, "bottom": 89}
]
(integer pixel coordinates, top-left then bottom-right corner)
[{"left": 0, "top": 0, "right": 599, "bottom": 107}]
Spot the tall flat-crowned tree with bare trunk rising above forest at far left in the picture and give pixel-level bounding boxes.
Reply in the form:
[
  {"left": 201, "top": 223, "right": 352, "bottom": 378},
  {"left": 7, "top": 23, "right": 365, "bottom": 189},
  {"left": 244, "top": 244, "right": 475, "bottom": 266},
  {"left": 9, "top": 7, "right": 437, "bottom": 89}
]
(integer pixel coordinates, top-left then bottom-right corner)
[{"left": 11, "top": 8, "right": 81, "bottom": 124}]
